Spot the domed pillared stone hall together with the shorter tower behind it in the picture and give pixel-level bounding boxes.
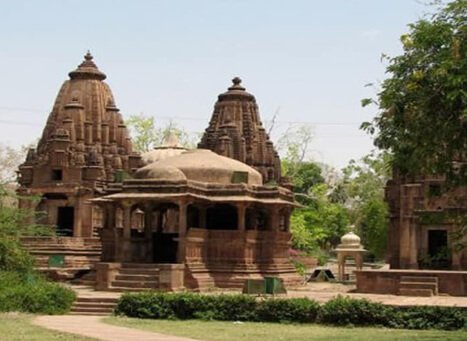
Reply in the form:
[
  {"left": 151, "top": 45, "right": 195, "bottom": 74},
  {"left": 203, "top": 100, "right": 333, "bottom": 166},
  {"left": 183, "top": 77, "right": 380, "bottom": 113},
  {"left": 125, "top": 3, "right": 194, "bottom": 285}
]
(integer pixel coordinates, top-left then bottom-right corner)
[{"left": 92, "top": 78, "right": 301, "bottom": 290}]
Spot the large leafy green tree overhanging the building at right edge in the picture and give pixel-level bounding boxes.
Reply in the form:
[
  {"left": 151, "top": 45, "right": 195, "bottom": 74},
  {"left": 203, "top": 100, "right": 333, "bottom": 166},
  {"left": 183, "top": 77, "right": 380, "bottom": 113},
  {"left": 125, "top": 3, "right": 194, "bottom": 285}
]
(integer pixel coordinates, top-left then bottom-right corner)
[{"left": 362, "top": 0, "right": 467, "bottom": 182}]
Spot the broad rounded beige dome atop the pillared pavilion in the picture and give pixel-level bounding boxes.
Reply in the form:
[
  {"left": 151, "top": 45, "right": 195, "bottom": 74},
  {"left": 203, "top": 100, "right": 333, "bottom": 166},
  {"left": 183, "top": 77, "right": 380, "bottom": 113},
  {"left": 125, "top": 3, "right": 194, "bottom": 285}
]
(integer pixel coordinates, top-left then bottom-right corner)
[{"left": 136, "top": 149, "right": 263, "bottom": 185}]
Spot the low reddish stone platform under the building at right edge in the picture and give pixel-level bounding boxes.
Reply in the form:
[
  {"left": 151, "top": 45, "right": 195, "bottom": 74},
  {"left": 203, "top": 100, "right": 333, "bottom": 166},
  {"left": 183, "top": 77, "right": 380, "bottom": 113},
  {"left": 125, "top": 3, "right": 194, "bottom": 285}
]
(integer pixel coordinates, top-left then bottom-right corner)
[{"left": 355, "top": 270, "right": 467, "bottom": 296}]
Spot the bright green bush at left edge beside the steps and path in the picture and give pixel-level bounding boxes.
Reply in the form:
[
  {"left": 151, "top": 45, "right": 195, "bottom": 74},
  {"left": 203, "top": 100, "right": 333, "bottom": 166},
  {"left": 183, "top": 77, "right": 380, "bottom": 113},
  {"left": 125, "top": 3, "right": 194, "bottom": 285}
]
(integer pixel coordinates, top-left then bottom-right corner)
[{"left": 0, "top": 271, "right": 76, "bottom": 314}]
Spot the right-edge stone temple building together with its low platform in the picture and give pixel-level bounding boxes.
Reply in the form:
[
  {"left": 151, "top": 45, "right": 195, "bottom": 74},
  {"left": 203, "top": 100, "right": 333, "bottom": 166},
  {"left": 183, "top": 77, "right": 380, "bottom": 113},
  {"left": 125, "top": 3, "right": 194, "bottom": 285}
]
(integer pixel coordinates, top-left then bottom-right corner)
[{"left": 357, "top": 170, "right": 467, "bottom": 296}]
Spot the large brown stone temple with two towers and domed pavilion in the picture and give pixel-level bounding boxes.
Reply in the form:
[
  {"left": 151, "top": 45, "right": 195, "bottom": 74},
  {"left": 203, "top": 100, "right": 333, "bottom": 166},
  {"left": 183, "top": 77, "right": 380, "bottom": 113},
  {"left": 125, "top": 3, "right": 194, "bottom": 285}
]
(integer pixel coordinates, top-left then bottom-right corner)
[{"left": 18, "top": 53, "right": 301, "bottom": 290}]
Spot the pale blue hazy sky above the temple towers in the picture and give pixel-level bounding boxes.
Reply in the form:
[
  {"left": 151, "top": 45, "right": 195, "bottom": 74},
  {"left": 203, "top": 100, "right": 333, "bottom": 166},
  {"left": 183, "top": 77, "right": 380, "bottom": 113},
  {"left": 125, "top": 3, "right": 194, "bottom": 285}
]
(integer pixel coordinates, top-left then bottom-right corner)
[{"left": 0, "top": 0, "right": 430, "bottom": 169}]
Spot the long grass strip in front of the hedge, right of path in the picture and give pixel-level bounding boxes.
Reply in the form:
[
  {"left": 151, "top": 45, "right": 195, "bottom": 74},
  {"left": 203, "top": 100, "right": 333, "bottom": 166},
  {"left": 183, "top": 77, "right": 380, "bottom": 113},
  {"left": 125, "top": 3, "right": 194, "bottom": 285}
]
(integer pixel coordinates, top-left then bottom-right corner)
[{"left": 104, "top": 317, "right": 467, "bottom": 341}]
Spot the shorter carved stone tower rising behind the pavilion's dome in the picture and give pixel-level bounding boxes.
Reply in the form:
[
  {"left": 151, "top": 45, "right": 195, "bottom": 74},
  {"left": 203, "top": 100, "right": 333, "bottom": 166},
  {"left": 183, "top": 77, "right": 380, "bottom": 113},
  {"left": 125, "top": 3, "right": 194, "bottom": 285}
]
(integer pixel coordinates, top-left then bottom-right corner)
[{"left": 198, "top": 77, "right": 282, "bottom": 183}]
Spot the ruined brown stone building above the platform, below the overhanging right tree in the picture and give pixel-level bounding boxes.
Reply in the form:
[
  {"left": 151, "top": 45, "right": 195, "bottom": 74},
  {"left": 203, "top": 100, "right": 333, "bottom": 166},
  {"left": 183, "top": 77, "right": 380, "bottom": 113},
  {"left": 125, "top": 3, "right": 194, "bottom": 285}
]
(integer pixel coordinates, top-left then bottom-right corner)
[{"left": 386, "top": 172, "right": 467, "bottom": 270}]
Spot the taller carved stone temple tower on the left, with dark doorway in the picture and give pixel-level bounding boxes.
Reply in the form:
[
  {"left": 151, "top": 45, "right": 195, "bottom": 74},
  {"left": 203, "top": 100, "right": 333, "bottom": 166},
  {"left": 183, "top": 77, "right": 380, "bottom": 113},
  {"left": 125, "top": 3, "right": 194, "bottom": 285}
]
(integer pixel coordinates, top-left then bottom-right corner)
[{"left": 18, "top": 52, "right": 140, "bottom": 237}]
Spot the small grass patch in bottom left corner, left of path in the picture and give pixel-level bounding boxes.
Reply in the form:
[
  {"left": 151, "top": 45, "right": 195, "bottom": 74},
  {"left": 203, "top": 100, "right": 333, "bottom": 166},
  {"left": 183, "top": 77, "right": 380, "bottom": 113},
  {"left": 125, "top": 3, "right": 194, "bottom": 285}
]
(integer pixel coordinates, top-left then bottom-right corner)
[{"left": 0, "top": 313, "right": 94, "bottom": 341}]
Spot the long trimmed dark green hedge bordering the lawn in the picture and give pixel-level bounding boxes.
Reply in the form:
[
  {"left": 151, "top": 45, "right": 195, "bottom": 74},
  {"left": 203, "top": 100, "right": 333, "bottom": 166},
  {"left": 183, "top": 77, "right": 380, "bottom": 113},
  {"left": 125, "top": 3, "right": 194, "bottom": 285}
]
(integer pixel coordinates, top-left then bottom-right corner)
[{"left": 115, "top": 292, "right": 467, "bottom": 330}]
